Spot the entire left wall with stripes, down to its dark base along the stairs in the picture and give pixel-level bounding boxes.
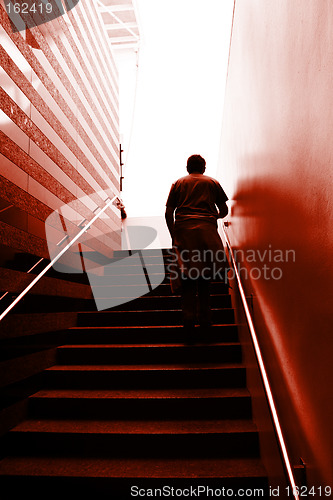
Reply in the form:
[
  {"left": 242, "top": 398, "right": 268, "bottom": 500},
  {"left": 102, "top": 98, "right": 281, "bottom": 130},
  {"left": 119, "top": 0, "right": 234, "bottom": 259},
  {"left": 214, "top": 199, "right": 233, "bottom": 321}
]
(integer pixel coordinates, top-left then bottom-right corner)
[{"left": 0, "top": 0, "right": 121, "bottom": 435}]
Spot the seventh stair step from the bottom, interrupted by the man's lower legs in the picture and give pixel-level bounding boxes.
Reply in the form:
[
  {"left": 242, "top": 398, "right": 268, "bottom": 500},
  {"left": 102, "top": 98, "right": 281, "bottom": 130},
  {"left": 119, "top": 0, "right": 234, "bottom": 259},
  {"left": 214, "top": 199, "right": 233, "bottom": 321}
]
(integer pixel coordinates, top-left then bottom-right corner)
[{"left": 78, "top": 308, "right": 235, "bottom": 326}]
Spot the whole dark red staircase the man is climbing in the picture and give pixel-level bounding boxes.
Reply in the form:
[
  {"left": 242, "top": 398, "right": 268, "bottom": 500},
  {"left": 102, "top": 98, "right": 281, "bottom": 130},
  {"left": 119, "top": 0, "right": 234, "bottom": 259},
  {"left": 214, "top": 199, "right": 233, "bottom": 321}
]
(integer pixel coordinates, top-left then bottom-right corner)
[{"left": 0, "top": 251, "right": 268, "bottom": 500}]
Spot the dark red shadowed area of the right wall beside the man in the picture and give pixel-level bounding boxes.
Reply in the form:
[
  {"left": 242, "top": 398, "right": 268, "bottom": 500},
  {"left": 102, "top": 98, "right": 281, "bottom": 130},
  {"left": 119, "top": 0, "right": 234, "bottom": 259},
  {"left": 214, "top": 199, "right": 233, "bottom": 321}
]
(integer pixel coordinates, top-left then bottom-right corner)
[{"left": 227, "top": 157, "right": 333, "bottom": 484}]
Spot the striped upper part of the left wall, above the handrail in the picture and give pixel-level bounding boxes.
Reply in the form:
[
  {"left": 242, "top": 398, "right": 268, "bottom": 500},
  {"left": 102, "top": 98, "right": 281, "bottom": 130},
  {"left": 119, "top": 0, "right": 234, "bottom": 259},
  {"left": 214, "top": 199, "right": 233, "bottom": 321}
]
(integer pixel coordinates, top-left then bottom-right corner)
[{"left": 0, "top": 0, "right": 121, "bottom": 265}]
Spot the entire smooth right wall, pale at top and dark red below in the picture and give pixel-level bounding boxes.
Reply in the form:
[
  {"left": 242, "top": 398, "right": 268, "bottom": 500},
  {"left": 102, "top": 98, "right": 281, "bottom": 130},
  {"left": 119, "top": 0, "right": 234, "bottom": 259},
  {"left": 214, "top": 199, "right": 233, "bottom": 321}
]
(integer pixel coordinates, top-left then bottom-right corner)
[{"left": 219, "top": 0, "right": 333, "bottom": 486}]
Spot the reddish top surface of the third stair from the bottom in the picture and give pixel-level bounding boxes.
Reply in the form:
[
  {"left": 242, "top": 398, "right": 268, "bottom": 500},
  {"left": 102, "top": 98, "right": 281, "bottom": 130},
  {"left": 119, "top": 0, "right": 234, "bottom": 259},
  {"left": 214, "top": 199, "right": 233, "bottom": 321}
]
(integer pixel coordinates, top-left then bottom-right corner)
[{"left": 30, "top": 387, "right": 250, "bottom": 399}]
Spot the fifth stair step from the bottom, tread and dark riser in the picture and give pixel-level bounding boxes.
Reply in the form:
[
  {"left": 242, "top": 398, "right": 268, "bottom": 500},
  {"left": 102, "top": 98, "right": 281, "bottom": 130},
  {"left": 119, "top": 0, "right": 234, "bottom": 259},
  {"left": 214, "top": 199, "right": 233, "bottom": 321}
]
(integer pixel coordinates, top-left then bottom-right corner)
[{"left": 57, "top": 343, "right": 242, "bottom": 365}]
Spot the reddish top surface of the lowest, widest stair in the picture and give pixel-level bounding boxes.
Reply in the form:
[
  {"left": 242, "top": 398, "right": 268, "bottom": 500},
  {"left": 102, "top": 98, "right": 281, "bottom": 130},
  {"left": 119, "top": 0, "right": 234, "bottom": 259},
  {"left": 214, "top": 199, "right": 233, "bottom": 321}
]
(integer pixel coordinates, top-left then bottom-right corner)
[{"left": 0, "top": 456, "right": 266, "bottom": 479}]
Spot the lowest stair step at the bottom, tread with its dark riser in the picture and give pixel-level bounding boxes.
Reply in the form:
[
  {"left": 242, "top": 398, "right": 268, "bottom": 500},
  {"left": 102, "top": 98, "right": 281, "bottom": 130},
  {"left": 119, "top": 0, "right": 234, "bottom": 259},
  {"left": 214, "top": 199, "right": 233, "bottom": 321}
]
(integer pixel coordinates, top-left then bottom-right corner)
[{"left": 0, "top": 462, "right": 270, "bottom": 500}]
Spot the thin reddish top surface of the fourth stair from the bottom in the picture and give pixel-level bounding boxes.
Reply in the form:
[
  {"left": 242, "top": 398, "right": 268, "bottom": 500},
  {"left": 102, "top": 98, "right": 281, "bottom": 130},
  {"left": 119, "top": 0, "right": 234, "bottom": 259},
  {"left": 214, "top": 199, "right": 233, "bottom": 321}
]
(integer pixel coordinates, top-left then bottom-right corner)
[{"left": 46, "top": 363, "right": 244, "bottom": 372}]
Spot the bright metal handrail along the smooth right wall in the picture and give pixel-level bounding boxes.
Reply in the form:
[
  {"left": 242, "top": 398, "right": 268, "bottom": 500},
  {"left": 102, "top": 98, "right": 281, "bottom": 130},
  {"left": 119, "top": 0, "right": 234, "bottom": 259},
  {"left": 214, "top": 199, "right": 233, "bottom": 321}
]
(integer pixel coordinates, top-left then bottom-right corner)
[{"left": 222, "top": 223, "right": 299, "bottom": 500}]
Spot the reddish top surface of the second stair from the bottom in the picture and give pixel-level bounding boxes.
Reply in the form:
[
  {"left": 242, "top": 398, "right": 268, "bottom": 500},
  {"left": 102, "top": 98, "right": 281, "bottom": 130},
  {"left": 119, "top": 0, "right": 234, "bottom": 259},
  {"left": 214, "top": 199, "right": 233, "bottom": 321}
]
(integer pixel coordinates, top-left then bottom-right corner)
[{"left": 11, "top": 419, "right": 257, "bottom": 434}]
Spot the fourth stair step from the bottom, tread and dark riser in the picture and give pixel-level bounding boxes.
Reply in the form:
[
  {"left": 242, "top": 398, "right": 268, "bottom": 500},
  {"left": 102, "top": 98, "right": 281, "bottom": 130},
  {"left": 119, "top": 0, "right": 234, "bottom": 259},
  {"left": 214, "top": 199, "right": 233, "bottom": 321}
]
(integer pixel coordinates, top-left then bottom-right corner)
[{"left": 43, "top": 363, "right": 246, "bottom": 389}]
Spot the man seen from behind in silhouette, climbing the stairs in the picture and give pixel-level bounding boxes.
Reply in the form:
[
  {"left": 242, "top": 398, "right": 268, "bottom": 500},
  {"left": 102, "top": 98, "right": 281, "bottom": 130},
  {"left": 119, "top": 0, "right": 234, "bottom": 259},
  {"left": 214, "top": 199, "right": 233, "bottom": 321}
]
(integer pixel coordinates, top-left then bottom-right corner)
[{"left": 165, "top": 155, "right": 228, "bottom": 341}]
